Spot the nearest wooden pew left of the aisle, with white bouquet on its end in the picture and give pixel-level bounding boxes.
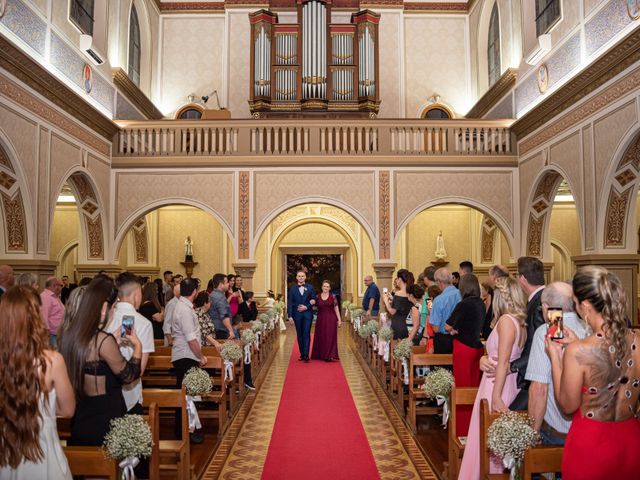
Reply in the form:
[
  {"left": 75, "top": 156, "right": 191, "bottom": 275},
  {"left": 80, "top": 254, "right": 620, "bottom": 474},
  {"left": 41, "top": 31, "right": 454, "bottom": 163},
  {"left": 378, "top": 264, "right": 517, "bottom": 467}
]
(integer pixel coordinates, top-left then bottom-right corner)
[{"left": 63, "top": 403, "right": 160, "bottom": 480}]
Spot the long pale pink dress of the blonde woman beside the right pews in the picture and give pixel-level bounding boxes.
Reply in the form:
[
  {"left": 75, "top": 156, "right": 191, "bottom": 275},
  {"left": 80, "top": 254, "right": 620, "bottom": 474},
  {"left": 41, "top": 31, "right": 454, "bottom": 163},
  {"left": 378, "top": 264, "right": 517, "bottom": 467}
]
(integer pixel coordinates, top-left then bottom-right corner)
[{"left": 458, "top": 315, "right": 522, "bottom": 480}]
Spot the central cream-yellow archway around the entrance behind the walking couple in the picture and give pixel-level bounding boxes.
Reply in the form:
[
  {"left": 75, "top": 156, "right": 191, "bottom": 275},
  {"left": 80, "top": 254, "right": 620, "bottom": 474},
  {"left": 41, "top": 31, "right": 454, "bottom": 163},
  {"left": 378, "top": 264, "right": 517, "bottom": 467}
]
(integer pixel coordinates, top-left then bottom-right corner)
[{"left": 253, "top": 203, "right": 375, "bottom": 300}]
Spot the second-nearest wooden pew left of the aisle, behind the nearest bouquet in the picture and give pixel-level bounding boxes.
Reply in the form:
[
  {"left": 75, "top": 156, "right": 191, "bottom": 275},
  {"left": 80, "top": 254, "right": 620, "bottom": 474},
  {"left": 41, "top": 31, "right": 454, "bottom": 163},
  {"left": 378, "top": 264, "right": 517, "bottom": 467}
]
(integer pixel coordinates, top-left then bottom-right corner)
[{"left": 142, "top": 387, "right": 191, "bottom": 480}]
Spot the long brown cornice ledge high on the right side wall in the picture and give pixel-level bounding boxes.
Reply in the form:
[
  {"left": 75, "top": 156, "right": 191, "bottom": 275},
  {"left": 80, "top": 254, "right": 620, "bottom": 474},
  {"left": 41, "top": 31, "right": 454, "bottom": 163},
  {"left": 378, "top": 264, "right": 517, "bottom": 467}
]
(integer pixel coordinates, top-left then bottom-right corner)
[{"left": 511, "top": 28, "right": 640, "bottom": 139}]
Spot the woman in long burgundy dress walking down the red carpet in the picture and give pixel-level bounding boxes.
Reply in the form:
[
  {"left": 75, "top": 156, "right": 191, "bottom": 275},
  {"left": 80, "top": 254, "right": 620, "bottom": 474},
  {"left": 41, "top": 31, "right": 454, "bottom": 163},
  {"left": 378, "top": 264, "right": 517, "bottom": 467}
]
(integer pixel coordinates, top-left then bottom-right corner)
[{"left": 311, "top": 280, "right": 342, "bottom": 362}]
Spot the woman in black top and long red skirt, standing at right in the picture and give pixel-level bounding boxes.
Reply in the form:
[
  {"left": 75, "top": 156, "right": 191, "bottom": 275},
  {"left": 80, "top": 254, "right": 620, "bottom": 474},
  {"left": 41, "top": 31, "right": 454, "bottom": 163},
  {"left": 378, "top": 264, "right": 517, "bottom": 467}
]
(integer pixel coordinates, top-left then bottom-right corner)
[{"left": 444, "top": 273, "right": 486, "bottom": 437}]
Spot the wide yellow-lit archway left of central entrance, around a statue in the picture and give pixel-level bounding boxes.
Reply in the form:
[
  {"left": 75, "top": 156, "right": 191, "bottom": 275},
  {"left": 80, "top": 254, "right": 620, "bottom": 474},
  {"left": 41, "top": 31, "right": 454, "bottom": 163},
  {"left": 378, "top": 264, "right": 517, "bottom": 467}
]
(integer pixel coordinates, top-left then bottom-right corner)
[{"left": 116, "top": 203, "right": 235, "bottom": 280}]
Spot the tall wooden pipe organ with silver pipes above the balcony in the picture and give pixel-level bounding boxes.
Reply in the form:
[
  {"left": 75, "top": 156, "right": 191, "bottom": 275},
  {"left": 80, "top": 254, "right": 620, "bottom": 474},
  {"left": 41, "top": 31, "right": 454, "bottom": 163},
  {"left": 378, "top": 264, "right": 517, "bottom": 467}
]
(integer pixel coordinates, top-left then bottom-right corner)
[{"left": 249, "top": 0, "right": 380, "bottom": 117}]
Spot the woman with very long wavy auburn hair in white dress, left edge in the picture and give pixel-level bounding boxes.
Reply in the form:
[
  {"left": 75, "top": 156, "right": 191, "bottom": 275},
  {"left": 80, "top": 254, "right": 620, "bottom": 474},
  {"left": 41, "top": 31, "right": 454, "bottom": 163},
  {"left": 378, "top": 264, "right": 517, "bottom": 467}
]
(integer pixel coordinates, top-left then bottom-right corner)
[{"left": 0, "top": 286, "right": 76, "bottom": 480}]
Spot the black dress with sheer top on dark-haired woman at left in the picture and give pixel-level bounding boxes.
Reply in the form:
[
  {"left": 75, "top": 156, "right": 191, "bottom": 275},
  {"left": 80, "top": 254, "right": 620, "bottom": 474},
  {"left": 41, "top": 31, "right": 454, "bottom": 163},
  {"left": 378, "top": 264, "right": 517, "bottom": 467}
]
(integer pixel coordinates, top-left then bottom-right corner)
[{"left": 69, "top": 331, "right": 140, "bottom": 446}]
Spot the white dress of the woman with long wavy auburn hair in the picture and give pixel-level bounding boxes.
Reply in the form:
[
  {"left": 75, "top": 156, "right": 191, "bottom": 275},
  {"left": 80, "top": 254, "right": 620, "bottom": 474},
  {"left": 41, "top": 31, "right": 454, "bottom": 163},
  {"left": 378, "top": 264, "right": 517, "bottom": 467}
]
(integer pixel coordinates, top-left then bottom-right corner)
[{"left": 0, "top": 389, "right": 72, "bottom": 480}]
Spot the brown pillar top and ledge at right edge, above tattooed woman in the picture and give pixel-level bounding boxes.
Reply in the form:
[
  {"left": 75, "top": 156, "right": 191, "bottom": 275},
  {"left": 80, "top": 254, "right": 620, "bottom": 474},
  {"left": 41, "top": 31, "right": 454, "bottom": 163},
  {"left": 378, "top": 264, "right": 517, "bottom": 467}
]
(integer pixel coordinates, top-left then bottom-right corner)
[{"left": 571, "top": 253, "right": 640, "bottom": 325}]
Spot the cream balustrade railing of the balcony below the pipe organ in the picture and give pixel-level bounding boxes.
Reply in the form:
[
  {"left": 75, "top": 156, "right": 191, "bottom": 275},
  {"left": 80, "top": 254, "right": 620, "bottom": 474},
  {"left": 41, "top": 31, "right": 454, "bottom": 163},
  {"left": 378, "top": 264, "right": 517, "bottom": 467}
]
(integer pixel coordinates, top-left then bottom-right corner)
[{"left": 113, "top": 119, "right": 515, "bottom": 158}]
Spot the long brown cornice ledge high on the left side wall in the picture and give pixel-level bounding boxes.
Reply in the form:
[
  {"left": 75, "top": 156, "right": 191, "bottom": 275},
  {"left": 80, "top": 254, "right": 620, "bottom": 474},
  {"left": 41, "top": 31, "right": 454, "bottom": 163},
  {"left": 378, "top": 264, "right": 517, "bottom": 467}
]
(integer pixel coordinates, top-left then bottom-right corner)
[{"left": 0, "top": 35, "right": 118, "bottom": 142}]
